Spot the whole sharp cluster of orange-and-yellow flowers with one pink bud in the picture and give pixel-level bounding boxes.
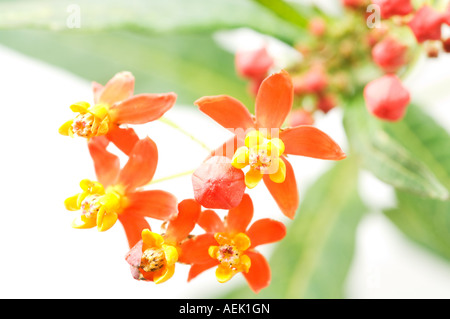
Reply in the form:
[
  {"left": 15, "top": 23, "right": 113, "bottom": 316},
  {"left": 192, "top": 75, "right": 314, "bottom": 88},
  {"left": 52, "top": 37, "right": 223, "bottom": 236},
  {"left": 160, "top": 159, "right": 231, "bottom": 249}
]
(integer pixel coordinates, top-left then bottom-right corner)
[{"left": 59, "top": 70, "right": 345, "bottom": 292}]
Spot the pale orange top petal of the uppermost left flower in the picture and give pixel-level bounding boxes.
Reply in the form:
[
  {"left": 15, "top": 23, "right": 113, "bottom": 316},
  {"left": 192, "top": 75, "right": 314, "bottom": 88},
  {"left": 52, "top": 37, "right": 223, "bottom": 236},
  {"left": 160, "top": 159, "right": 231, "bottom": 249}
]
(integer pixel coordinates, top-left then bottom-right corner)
[{"left": 94, "top": 72, "right": 134, "bottom": 105}]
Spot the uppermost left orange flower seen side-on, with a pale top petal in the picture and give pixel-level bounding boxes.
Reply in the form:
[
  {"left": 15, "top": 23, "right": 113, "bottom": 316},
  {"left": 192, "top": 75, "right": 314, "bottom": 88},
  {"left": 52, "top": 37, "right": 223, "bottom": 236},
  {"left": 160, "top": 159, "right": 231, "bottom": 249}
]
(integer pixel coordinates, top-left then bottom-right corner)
[{"left": 59, "top": 72, "right": 176, "bottom": 154}]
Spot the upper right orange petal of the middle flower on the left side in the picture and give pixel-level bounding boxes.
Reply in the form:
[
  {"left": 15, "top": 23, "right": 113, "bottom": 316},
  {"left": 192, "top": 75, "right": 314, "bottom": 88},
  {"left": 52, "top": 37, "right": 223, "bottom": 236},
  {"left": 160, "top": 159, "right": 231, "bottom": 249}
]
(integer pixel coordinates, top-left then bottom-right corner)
[{"left": 118, "top": 137, "right": 158, "bottom": 190}]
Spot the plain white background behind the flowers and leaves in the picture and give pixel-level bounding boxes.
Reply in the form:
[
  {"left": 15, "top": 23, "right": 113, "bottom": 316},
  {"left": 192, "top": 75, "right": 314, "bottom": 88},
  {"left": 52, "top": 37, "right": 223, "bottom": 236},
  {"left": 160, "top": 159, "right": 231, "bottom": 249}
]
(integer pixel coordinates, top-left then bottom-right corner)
[{"left": 0, "top": 25, "right": 450, "bottom": 298}]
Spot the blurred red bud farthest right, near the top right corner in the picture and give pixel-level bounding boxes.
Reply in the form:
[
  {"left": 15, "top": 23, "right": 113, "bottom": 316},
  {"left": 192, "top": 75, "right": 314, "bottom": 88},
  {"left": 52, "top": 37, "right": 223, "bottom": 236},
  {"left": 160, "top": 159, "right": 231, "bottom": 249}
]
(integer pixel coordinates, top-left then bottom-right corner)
[{"left": 408, "top": 6, "right": 445, "bottom": 43}]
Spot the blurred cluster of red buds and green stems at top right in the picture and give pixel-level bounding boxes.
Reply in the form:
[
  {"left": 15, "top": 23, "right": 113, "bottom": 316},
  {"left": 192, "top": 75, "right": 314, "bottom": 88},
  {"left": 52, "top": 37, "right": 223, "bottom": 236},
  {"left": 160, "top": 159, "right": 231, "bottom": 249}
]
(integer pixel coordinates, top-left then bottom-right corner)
[{"left": 236, "top": 0, "right": 450, "bottom": 126}]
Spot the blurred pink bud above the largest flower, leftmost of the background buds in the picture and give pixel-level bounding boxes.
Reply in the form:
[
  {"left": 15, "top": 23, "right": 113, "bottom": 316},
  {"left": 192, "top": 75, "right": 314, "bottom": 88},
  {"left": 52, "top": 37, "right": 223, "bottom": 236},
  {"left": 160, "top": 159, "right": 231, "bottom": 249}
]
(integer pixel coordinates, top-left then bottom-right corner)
[{"left": 235, "top": 47, "right": 274, "bottom": 79}]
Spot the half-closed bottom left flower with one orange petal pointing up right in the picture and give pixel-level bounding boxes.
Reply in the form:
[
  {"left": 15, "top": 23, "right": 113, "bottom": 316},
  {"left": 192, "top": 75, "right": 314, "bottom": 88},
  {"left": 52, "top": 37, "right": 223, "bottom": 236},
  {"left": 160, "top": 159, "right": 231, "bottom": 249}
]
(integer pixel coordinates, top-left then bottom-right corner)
[{"left": 125, "top": 199, "right": 201, "bottom": 284}]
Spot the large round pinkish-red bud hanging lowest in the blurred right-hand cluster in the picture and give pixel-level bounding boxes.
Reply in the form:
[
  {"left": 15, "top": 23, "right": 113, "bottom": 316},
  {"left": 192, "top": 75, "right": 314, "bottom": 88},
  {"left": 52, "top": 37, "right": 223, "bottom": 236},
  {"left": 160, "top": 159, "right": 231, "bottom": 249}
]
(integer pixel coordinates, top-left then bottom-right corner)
[{"left": 364, "top": 74, "right": 410, "bottom": 121}]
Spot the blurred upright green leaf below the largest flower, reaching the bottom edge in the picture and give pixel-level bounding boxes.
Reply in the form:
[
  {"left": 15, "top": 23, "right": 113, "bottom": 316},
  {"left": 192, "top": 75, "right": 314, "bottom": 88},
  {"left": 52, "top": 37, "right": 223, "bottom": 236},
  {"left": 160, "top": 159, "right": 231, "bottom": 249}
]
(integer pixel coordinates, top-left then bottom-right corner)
[{"left": 221, "top": 157, "right": 366, "bottom": 298}]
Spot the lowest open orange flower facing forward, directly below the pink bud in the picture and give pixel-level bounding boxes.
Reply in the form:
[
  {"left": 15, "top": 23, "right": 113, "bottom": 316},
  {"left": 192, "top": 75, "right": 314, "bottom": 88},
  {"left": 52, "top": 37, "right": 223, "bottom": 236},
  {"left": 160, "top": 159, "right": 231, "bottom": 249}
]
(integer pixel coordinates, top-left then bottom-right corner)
[{"left": 179, "top": 194, "right": 286, "bottom": 293}]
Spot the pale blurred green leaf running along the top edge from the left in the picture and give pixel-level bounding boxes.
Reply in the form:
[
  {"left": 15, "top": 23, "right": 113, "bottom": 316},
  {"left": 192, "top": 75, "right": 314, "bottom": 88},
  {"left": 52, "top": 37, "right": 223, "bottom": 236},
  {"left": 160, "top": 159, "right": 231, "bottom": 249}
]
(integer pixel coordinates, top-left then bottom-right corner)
[{"left": 0, "top": 0, "right": 301, "bottom": 43}]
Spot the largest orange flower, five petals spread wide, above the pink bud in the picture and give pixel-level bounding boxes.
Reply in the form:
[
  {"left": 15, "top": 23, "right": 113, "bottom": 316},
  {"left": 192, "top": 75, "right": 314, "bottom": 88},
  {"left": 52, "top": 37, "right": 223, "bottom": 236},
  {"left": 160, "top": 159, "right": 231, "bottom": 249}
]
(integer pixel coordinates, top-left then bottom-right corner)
[{"left": 195, "top": 70, "right": 346, "bottom": 218}]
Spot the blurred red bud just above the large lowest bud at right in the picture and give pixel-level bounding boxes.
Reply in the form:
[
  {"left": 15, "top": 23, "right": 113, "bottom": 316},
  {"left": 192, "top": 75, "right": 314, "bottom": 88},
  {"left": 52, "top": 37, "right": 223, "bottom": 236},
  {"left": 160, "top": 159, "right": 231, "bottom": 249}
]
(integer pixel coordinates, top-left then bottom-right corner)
[{"left": 372, "top": 37, "right": 408, "bottom": 73}]
